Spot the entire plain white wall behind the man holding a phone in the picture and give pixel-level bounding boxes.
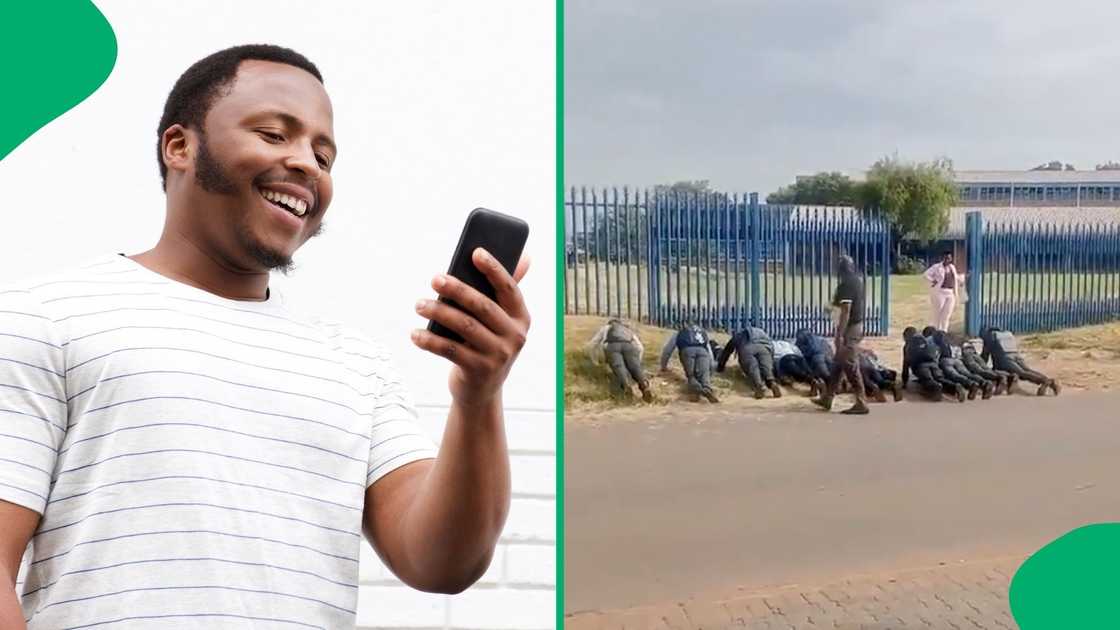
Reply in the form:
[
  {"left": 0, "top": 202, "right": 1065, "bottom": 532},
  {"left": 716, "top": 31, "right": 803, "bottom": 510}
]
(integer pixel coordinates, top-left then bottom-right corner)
[{"left": 0, "top": 0, "right": 556, "bottom": 629}]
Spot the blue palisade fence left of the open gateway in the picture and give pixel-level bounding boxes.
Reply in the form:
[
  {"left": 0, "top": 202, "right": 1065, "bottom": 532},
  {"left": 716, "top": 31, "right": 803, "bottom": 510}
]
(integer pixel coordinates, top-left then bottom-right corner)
[{"left": 564, "top": 188, "right": 890, "bottom": 336}]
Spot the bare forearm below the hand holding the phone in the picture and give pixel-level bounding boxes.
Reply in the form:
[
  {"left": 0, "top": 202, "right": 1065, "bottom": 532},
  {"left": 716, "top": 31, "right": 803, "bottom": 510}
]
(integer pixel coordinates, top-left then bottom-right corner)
[{"left": 402, "top": 398, "right": 510, "bottom": 592}]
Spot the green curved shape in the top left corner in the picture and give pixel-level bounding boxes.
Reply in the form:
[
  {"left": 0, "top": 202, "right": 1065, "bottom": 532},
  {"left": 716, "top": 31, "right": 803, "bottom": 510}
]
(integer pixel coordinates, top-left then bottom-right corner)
[{"left": 0, "top": 0, "right": 116, "bottom": 159}]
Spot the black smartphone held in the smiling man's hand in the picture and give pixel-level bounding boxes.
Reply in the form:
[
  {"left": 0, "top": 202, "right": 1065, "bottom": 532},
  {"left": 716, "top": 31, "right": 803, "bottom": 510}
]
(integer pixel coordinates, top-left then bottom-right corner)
[{"left": 428, "top": 207, "right": 529, "bottom": 342}]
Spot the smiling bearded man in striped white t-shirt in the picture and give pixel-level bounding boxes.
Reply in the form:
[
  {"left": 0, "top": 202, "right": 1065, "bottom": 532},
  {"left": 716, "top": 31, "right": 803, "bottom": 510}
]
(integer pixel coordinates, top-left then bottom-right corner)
[{"left": 0, "top": 46, "right": 530, "bottom": 629}]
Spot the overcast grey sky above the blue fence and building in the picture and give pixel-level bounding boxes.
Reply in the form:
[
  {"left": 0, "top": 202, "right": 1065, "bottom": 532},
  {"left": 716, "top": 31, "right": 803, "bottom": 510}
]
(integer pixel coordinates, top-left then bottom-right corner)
[{"left": 564, "top": 0, "right": 1120, "bottom": 196}]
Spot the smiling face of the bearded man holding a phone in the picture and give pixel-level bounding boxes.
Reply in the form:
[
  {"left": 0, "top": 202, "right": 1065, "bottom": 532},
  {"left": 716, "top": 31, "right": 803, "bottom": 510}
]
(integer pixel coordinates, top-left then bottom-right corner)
[{"left": 172, "top": 61, "right": 336, "bottom": 272}]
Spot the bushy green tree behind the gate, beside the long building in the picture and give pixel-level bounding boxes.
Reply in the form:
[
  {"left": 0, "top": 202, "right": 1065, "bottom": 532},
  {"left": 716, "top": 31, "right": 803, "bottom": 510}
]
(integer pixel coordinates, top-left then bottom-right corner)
[{"left": 858, "top": 157, "right": 959, "bottom": 264}]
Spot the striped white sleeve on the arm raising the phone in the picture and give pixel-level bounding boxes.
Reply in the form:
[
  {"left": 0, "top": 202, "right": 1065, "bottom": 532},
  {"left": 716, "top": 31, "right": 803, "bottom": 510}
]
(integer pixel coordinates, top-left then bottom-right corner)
[{"left": 365, "top": 352, "right": 437, "bottom": 488}]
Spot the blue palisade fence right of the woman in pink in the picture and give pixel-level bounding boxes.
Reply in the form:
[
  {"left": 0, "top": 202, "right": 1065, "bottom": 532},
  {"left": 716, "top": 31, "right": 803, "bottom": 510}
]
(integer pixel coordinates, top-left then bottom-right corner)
[{"left": 964, "top": 211, "right": 1120, "bottom": 335}]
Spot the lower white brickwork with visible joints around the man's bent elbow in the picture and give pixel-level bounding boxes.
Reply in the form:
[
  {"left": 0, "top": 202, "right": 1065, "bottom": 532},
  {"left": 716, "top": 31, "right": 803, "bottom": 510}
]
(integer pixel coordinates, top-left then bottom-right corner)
[{"left": 357, "top": 407, "right": 557, "bottom": 630}]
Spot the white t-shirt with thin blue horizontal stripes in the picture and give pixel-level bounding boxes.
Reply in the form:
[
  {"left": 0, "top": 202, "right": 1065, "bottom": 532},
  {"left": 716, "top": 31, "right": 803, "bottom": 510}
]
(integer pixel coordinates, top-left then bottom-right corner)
[{"left": 0, "top": 254, "right": 436, "bottom": 630}]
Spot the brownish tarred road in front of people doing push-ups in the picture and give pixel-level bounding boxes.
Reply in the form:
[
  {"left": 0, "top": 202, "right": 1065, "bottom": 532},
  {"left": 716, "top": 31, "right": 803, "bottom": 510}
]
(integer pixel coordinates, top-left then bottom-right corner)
[{"left": 564, "top": 393, "right": 1120, "bottom": 629}]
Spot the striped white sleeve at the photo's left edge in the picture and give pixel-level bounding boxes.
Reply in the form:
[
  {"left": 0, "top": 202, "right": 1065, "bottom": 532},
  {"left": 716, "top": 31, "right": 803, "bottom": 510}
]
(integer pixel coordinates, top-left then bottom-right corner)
[{"left": 0, "top": 288, "right": 67, "bottom": 515}]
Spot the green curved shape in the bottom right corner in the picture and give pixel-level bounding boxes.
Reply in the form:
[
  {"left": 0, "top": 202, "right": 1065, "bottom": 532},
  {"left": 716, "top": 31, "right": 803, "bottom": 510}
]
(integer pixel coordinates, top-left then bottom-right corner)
[{"left": 1008, "top": 522, "right": 1120, "bottom": 630}]
